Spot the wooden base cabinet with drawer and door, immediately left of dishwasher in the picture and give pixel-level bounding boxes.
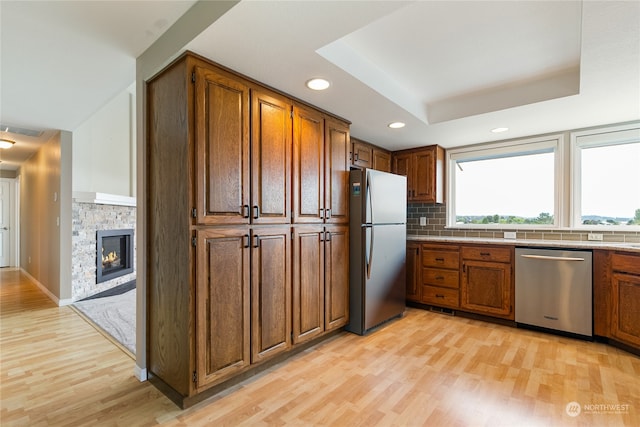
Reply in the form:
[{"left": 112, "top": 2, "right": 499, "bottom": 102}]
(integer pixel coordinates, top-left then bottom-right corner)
[{"left": 460, "top": 246, "right": 515, "bottom": 320}]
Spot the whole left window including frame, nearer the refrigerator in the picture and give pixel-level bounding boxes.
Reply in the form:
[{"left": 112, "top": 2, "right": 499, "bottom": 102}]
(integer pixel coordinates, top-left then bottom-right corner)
[{"left": 447, "top": 136, "right": 562, "bottom": 228}]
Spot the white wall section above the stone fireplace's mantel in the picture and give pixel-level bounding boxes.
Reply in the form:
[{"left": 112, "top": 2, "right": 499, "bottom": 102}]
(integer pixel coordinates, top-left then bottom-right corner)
[{"left": 72, "top": 84, "right": 136, "bottom": 196}]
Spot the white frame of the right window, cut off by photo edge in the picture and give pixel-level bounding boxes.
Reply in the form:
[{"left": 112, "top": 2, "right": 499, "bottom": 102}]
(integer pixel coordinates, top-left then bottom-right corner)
[{"left": 569, "top": 122, "right": 640, "bottom": 231}]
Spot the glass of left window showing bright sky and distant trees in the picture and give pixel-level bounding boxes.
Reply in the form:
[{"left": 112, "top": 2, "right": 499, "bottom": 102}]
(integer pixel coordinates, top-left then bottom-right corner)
[{"left": 454, "top": 149, "right": 555, "bottom": 225}]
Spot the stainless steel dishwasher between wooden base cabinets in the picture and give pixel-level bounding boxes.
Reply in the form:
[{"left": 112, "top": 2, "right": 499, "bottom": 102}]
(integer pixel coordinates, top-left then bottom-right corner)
[{"left": 515, "top": 248, "right": 593, "bottom": 337}]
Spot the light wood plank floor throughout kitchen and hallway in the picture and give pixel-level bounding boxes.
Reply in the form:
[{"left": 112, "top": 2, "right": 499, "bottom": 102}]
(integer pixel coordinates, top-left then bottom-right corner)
[{"left": 0, "top": 270, "right": 640, "bottom": 426}]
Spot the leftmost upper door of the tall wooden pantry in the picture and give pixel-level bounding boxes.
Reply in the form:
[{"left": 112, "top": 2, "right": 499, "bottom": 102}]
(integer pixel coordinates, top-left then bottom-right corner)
[{"left": 194, "top": 67, "right": 249, "bottom": 224}]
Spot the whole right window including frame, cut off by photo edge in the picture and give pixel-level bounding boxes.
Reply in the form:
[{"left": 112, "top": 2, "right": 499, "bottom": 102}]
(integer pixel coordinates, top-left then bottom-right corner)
[{"left": 571, "top": 124, "right": 640, "bottom": 229}]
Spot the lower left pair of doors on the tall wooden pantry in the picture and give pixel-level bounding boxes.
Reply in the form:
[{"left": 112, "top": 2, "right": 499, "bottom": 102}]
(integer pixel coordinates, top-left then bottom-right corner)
[{"left": 194, "top": 227, "right": 291, "bottom": 388}]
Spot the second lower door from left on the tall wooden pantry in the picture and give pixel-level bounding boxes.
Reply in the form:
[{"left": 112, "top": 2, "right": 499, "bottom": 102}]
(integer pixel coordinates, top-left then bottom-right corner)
[{"left": 251, "top": 227, "right": 291, "bottom": 363}]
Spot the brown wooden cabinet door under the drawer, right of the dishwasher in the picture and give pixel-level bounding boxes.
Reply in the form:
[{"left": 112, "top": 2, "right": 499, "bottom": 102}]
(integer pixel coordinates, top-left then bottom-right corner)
[{"left": 611, "top": 272, "right": 640, "bottom": 347}]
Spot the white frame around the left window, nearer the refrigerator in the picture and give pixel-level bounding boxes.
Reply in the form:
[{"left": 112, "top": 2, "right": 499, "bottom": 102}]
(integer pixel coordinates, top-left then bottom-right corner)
[{"left": 446, "top": 134, "right": 566, "bottom": 230}]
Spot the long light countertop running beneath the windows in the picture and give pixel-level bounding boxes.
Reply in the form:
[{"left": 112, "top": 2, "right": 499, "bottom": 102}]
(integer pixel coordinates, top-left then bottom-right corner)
[{"left": 407, "top": 235, "right": 640, "bottom": 253}]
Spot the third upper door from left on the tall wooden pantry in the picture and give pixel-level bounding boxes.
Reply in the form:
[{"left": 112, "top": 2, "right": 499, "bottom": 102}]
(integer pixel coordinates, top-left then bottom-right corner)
[{"left": 293, "top": 106, "right": 325, "bottom": 223}]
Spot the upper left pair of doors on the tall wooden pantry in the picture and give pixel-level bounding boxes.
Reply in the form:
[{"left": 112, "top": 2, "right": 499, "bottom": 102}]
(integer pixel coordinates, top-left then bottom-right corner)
[{"left": 195, "top": 67, "right": 292, "bottom": 225}]
